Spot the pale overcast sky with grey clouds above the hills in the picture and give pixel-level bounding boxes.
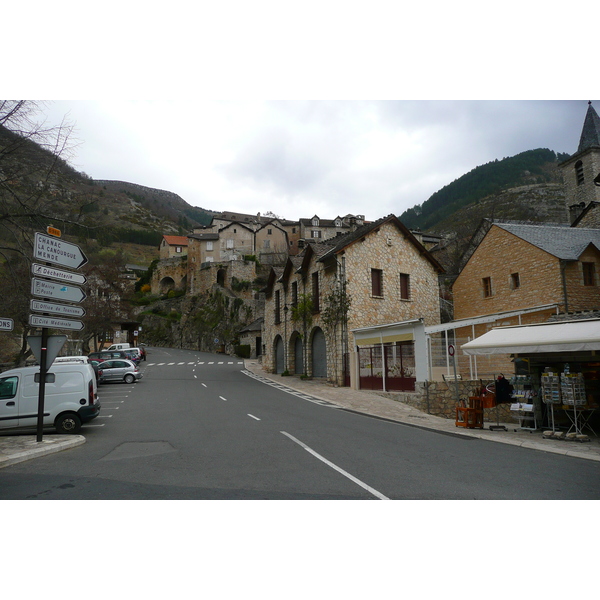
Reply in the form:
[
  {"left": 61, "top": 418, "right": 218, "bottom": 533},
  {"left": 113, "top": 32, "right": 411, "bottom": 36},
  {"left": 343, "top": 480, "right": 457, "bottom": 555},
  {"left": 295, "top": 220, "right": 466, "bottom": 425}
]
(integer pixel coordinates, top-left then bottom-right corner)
[{"left": 45, "top": 100, "right": 600, "bottom": 220}]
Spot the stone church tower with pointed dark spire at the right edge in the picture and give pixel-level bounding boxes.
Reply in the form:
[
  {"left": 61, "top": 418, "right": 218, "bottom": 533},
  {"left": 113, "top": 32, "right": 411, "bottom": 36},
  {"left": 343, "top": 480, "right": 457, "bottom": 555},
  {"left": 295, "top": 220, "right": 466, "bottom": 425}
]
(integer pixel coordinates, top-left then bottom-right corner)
[{"left": 560, "top": 102, "right": 600, "bottom": 227}]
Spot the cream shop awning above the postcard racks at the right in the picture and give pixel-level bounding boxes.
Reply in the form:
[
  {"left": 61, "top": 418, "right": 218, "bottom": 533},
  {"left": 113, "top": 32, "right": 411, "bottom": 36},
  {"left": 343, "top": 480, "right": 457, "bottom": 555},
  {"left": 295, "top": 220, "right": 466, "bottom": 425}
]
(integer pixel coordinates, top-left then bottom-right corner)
[{"left": 461, "top": 319, "right": 600, "bottom": 354}]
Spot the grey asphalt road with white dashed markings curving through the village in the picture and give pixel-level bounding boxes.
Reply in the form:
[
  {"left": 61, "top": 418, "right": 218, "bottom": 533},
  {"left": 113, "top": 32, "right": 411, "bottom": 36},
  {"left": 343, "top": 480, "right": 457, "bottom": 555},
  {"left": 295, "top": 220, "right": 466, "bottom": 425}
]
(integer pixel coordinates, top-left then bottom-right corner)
[{"left": 0, "top": 348, "right": 600, "bottom": 500}]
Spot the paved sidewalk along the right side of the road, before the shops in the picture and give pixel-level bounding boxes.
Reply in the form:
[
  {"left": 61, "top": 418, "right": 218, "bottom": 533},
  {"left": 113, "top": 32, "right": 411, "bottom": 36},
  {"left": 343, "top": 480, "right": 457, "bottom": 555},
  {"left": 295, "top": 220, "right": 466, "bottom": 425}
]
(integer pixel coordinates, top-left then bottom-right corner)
[{"left": 244, "top": 359, "right": 600, "bottom": 462}]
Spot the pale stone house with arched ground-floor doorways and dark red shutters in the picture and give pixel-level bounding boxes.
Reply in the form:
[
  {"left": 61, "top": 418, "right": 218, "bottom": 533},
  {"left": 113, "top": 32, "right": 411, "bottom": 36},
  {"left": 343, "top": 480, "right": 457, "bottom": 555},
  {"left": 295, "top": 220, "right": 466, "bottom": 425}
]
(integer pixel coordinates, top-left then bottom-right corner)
[{"left": 262, "top": 215, "right": 443, "bottom": 390}]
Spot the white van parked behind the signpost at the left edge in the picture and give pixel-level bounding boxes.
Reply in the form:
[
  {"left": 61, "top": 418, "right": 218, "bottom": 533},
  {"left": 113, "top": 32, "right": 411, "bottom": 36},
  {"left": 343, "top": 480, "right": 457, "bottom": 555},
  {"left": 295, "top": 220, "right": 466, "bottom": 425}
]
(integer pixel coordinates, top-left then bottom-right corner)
[{"left": 0, "top": 363, "right": 100, "bottom": 433}]
